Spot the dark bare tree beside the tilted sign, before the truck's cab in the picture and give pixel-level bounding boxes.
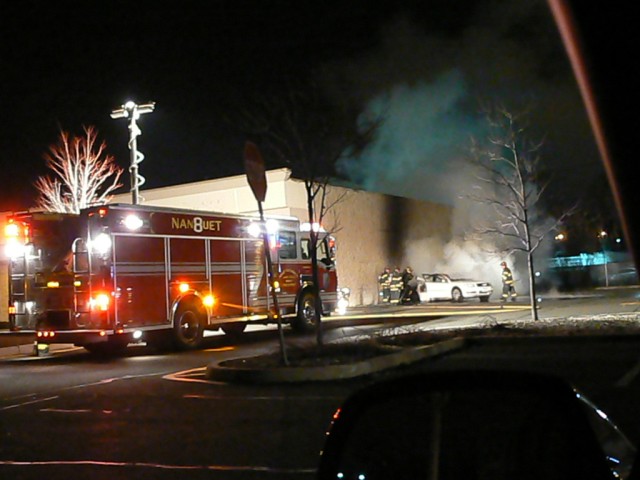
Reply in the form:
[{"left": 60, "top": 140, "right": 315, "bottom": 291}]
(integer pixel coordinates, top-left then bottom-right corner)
[{"left": 230, "top": 83, "right": 379, "bottom": 345}]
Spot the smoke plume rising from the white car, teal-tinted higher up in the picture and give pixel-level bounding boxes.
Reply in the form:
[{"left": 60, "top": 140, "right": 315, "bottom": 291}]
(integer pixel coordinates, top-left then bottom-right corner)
[{"left": 330, "top": 1, "right": 597, "bottom": 293}]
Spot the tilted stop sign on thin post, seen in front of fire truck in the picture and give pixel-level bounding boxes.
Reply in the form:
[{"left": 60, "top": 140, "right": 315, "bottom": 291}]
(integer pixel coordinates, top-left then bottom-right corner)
[{"left": 244, "top": 141, "right": 289, "bottom": 365}]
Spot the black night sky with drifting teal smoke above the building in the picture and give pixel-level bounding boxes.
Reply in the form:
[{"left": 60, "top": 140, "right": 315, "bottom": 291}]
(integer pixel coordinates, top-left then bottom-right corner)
[{"left": 0, "top": 0, "right": 602, "bottom": 215}]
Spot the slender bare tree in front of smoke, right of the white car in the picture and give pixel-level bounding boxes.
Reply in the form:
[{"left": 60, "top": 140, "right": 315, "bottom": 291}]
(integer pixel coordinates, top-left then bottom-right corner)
[{"left": 469, "top": 106, "right": 575, "bottom": 320}]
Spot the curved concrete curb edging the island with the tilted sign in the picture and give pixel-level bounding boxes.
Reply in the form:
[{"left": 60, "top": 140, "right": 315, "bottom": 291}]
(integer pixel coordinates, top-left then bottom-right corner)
[{"left": 206, "top": 338, "right": 465, "bottom": 383}]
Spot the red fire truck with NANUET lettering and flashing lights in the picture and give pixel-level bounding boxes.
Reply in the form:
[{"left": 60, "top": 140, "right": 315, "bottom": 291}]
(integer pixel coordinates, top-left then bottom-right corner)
[{"left": 5, "top": 204, "right": 338, "bottom": 352}]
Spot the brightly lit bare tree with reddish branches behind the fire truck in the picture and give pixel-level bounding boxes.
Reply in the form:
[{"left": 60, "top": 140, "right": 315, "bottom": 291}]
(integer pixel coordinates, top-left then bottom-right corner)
[{"left": 35, "top": 127, "right": 123, "bottom": 213}]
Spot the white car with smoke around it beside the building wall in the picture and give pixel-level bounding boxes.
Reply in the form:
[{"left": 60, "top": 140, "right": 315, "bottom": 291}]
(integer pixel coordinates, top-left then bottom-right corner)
[{"left": 418, "top": 273, "right": 493, "bottom": 302}]
